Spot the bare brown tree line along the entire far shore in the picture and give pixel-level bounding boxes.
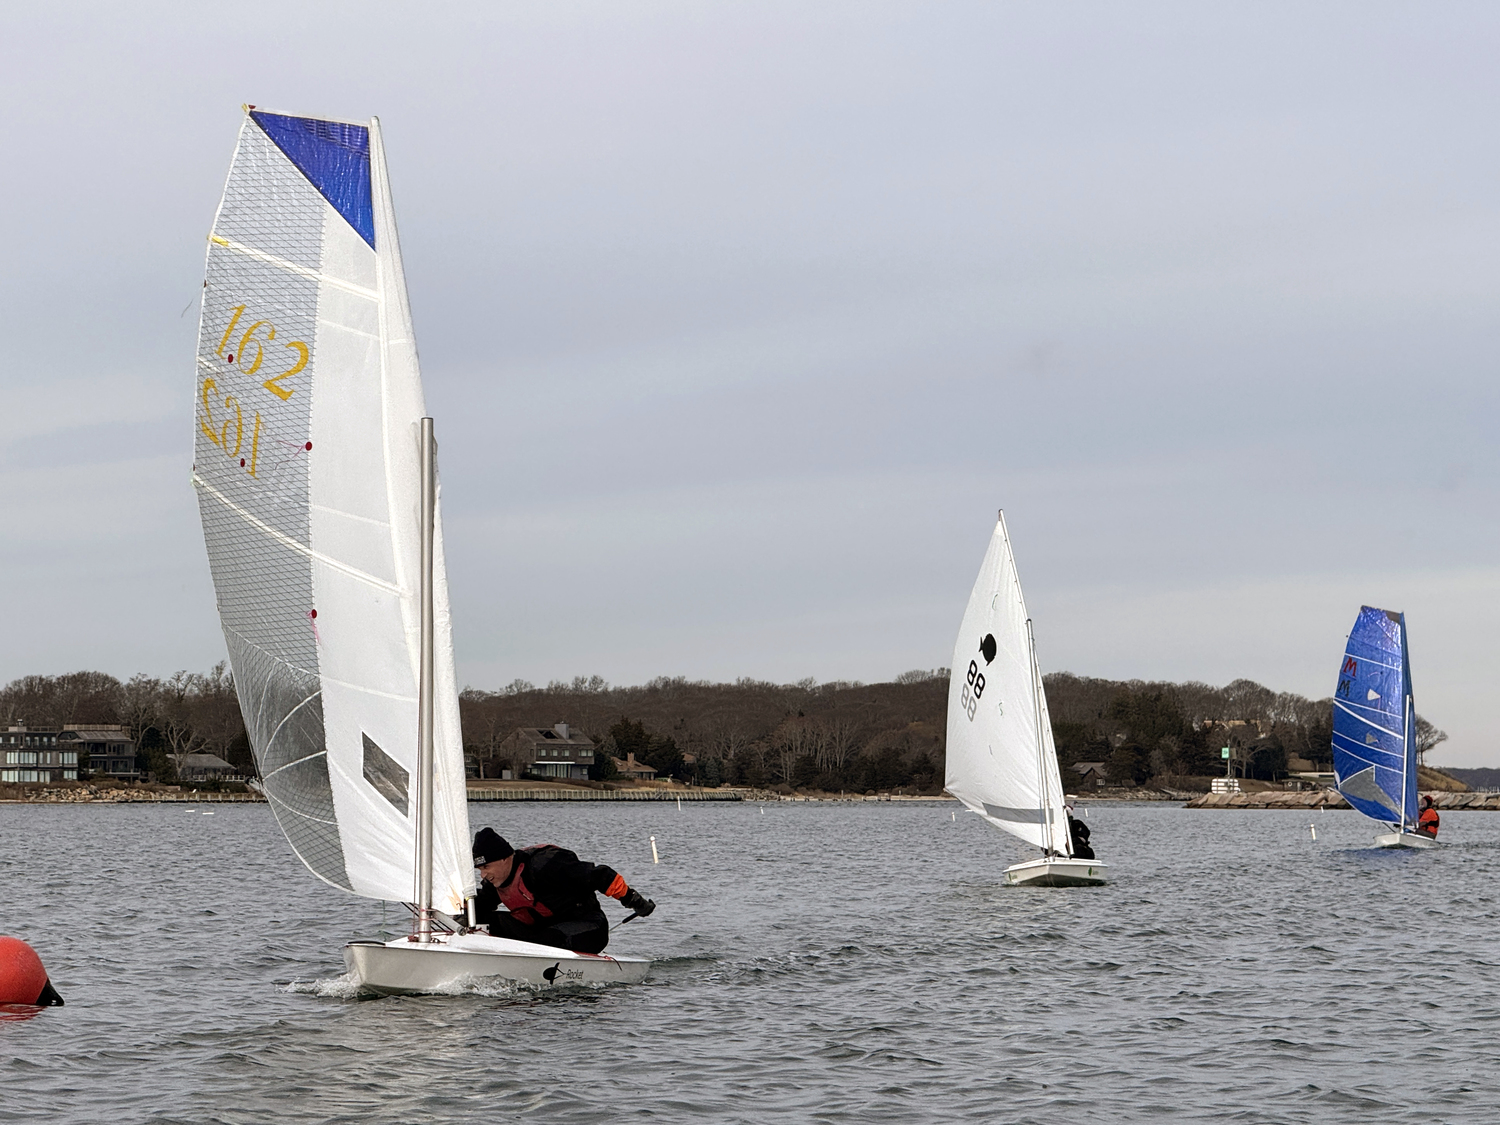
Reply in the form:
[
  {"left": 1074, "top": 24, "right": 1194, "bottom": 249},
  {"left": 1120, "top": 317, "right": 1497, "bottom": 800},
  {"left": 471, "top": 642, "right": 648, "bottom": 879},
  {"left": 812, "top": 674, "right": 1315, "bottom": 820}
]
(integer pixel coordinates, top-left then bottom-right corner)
[{"left": 0, "top": 663, "right": 1448, "bottom": 794}]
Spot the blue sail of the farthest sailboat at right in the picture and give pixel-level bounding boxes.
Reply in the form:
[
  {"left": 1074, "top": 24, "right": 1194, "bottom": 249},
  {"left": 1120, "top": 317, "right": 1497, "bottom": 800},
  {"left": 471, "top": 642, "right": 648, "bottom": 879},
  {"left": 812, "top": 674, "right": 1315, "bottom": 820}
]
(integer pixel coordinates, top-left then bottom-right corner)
[{"left": 1334, "top": 606, "right": 1416, "bottom": 828}]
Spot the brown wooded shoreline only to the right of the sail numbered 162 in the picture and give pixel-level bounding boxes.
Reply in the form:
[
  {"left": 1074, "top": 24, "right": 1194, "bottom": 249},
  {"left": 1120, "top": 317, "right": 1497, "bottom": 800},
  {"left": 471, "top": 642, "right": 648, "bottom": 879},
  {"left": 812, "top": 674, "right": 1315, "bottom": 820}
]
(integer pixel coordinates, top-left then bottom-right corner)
[{"left": 459, "top": 669, "right": 1448, "bottom": 794}]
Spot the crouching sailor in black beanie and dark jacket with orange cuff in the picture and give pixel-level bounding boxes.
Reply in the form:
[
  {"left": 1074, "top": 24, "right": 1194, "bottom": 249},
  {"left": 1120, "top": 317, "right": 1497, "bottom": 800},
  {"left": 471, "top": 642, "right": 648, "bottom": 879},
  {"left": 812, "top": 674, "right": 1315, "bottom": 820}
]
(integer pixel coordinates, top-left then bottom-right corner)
[{"left": 474, "top": 828, "right": 656, "bottom": 953}]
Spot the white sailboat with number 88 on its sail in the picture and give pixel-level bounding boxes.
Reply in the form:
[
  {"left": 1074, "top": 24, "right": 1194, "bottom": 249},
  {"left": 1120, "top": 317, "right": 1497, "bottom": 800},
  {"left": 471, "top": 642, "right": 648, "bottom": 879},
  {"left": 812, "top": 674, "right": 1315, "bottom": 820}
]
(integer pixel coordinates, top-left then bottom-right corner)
[{"left": 947, "top": 512, "right": 1107, "bottom": 887}]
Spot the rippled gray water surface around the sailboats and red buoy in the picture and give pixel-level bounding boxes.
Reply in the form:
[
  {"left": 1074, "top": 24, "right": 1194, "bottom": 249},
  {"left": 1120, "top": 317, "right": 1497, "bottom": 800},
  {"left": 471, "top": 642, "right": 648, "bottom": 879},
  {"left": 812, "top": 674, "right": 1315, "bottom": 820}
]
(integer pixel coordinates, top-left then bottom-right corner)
[{"left": 0, "top": 803, "right": 1500, "bottom": 1125}]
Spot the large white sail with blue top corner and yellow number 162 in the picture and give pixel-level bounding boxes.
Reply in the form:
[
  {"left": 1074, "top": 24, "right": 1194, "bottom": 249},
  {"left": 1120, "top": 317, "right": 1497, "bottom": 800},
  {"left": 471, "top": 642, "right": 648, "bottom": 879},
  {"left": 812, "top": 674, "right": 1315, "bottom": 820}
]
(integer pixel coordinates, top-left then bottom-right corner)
[{"left": 194, "top": 107, "right": 473, "bottom": 912}]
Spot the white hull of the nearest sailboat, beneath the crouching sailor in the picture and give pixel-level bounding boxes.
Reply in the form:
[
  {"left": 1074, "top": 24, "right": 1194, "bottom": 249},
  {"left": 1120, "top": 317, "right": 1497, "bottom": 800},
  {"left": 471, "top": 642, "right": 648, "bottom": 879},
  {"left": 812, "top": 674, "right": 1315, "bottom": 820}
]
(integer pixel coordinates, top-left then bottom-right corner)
[{"left": 344, "top": 933, "right": 651, "bottom": 996}]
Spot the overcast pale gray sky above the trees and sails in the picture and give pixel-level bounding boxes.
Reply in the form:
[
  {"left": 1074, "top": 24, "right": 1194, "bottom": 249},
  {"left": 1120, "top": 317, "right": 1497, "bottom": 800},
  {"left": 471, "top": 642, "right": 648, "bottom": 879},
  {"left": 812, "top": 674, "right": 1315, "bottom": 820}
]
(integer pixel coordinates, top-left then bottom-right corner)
[{"left": 0, "top": 0, "right": 1500, "bottom": 765}]
